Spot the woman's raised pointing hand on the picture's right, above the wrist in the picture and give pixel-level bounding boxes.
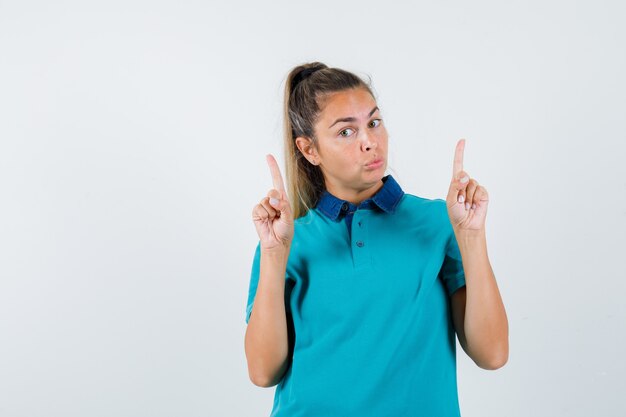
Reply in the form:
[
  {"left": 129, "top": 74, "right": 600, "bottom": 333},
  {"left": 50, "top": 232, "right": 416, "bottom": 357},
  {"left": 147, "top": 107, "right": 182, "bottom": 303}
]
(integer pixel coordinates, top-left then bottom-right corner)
[{"left": 446, "top": 139, "right": 489, "bottom": 232}]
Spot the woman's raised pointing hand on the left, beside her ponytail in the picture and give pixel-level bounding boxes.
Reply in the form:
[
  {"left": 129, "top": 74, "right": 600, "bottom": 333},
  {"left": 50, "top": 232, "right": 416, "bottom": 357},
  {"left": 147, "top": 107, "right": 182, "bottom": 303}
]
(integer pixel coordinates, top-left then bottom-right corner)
[{"left": 252, "top": 155, "right": 293, "bottom": 251}]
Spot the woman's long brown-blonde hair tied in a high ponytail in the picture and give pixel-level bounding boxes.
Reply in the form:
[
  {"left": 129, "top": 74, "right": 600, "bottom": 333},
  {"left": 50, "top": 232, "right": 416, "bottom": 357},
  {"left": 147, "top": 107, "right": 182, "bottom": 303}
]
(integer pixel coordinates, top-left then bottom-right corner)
[{"left": 283, "top": 62, "right": 374, "bottom": 219}]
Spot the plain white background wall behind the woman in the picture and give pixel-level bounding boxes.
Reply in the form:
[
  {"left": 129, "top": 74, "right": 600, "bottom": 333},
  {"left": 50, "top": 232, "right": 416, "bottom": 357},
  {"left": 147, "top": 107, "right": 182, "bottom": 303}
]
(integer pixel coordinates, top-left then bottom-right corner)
[{"left": 0, "top": 0, "right": 626, "bottom": 417}]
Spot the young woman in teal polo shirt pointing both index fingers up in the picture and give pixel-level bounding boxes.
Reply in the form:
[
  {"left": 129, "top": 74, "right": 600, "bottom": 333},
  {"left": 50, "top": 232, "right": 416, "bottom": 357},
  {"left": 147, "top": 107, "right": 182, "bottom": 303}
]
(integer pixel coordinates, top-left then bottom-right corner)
[{"left": 245, "top": 62, "right": 508, "bottom": 417}]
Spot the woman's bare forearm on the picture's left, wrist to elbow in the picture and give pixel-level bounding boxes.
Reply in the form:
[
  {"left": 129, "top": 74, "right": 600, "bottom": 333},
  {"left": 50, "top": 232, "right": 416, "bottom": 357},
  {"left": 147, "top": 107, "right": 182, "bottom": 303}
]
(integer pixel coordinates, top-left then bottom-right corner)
[{"left": 245, "top": 247, "right": 289, "bottom": 387}]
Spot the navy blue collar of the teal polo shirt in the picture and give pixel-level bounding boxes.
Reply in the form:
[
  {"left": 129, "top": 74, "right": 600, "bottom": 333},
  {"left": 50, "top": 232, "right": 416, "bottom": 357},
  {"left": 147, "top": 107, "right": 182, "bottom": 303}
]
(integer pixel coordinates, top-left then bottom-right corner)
[{"left": 315, "top": 175, "right": 404, "bottom": 221}]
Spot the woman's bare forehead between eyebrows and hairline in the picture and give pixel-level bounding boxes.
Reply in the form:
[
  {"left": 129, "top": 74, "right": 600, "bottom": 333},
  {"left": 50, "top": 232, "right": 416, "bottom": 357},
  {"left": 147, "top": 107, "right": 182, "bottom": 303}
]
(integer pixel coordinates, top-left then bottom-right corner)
[{"left": 319, "top": 88, "right": 376, "bottom": 126}]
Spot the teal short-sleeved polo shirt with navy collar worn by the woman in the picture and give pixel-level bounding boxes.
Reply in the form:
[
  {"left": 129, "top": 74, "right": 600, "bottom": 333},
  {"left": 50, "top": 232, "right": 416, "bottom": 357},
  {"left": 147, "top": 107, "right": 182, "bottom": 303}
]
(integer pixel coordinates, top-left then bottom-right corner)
[{"left": 246, "top": 175, "right": 465, "bottom": 417}]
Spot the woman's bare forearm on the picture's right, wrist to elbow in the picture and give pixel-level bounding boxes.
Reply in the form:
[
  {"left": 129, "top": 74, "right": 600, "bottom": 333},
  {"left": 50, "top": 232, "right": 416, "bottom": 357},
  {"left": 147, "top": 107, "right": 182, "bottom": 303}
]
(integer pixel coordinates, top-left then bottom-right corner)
[{"left": 456, "top": 229, "right": 509, "bottom": 369}]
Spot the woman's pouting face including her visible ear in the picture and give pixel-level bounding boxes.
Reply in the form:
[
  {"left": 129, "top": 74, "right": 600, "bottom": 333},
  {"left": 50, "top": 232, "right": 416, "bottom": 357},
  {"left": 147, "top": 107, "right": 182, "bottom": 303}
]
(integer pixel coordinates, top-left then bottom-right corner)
[{"left": 296, "top": 88, "right": 388, "bottom": 200}]
